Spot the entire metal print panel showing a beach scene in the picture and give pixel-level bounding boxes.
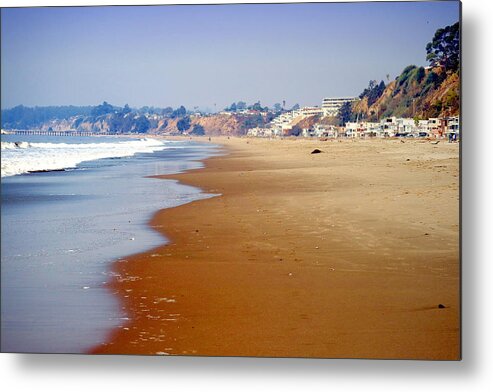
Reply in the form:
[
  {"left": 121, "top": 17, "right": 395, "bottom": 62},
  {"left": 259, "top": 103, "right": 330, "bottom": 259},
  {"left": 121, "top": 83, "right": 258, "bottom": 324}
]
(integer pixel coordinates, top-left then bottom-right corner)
[{"left": 1, "top": 1, "right": 462, "bottom": 360}]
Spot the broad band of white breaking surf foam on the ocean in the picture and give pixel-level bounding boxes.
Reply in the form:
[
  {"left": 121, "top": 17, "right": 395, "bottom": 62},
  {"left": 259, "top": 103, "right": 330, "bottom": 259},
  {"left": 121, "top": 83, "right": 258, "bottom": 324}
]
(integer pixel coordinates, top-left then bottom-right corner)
[{"left": 1, "top": 138, "right": 167, "bottom": 177}]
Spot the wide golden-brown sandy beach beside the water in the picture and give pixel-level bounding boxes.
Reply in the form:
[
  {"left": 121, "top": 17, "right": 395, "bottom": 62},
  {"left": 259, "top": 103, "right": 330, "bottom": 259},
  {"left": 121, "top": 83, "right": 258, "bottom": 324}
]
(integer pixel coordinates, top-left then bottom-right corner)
[{"left": 91, "top": 138, "right": 460, "bottom": 360}]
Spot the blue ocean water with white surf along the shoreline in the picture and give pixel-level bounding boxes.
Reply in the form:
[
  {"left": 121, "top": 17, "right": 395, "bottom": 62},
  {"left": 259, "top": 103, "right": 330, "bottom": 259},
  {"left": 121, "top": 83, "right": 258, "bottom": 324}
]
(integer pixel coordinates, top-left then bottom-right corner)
[{"left": 1, "top": 135, "right": 219, "bottom": 353}]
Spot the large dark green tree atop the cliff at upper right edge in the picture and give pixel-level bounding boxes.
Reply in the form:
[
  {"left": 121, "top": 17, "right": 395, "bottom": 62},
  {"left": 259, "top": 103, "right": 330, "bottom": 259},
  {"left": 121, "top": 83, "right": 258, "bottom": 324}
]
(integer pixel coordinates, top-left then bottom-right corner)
[{"left": 426, "top": 22, "right": 460, "bottom": 72}]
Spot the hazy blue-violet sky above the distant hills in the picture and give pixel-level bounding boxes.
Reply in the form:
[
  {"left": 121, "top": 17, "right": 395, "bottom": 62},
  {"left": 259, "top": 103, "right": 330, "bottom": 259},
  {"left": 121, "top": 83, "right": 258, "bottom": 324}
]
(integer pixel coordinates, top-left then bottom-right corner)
[{"left": 1, "top": 1, "right": 459, "bottom": 110}]
